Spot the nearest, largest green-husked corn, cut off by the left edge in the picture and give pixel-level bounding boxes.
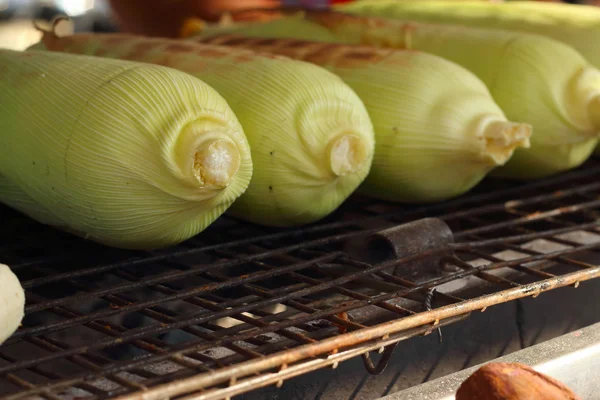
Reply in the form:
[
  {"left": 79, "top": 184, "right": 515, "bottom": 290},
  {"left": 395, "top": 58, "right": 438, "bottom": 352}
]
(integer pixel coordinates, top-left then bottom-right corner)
[{"left": 0, "top": 50, "right": 252, "bottom": 249}]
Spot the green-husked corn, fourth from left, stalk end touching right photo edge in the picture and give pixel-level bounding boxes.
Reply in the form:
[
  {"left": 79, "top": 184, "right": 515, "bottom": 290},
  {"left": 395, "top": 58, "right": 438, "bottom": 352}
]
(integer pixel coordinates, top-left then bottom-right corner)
[{"left": 200, "top": 12, "right": 600, "bottom": 179}]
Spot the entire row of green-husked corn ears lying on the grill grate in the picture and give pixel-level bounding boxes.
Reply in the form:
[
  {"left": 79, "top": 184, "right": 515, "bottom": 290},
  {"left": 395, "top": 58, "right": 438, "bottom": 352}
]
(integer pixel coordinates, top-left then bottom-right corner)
[{"left": 0, "top": 0, "right": 600, "bottom": 249}]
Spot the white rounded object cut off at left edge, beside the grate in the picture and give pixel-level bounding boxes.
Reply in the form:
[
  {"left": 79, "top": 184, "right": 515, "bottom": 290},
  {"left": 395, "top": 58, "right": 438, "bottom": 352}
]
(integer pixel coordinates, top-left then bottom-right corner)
[{"left": 0, "top": 264, "right": 25, "bottom": 344}]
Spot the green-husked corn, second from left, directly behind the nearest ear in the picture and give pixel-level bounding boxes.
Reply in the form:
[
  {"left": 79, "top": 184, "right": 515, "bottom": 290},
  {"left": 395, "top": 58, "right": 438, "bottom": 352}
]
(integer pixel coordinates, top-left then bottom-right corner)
[{"left": 31, "top": 29, "right": 375, "bottom": 226}]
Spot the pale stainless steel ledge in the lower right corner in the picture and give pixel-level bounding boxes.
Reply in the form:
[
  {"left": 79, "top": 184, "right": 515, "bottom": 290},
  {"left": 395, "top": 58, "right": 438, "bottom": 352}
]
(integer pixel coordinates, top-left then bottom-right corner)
[{"left": 379, "top": 323, "right": 600, "bottom": 400}]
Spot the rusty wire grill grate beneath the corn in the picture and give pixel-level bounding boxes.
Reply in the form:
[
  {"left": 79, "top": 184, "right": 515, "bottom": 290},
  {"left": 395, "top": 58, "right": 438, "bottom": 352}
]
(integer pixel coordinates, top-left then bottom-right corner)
[{"left": 0, "top": 161, "right": 600, "bottom": 400}]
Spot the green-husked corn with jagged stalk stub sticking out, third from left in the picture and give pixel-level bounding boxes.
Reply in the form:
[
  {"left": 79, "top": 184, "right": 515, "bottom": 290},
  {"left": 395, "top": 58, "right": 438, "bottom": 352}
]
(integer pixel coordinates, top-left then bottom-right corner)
[{"left": 202, "top": 35, "right": 531, "bottom": 203}]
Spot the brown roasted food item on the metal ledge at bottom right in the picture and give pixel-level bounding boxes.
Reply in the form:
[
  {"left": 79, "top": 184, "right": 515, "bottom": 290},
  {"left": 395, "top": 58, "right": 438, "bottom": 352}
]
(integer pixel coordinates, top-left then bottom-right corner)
[{"left": 456, "top": 363, "right": 581, "bottom": 400}]
